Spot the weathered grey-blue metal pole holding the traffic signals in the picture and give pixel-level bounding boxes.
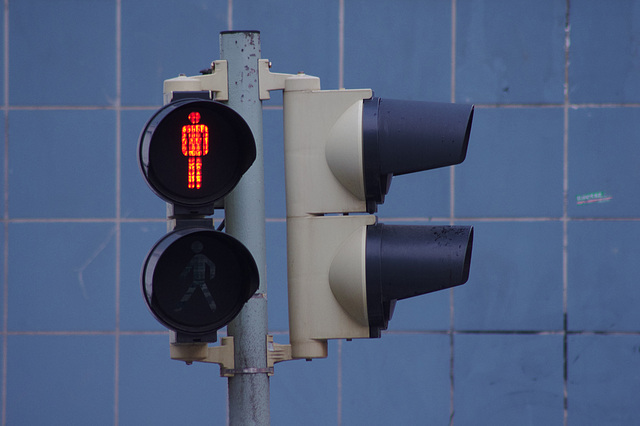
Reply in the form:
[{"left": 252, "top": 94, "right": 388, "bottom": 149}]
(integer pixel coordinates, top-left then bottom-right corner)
[{"left": 220, "top": 31, "right": 269, "bottom": 426}]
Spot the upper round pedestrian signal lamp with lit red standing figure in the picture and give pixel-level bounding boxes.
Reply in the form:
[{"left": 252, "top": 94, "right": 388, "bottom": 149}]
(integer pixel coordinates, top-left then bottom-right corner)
[{"left": 138, "top": 99, "right": 256, "bottom": 214}]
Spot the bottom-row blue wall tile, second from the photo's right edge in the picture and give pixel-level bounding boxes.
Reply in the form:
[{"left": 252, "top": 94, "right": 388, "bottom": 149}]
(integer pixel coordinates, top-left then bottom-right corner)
[{"left": 453, "top": 334, "right": 564, "bottom": 426}]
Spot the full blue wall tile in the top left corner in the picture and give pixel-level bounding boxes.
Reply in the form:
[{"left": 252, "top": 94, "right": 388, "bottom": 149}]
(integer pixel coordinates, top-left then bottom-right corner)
[{"left": 9, "top": 0, "right": 116, "bottom": 105}]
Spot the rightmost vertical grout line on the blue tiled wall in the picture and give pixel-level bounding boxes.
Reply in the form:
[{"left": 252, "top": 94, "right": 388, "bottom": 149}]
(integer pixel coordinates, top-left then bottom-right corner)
[{"left": 562, "top": 0, "right": 571, "bottom": 426}]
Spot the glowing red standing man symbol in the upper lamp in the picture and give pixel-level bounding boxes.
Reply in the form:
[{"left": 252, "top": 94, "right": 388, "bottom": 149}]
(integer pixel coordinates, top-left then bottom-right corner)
[{"left": 182, "top": 111, "right": 209, "bottom": 189}]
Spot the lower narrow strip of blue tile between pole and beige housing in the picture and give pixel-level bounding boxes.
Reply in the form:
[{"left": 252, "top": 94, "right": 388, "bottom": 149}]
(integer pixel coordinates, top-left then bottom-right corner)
[{"left": 266, "top": 222, "right": 289, "bottom": 331}]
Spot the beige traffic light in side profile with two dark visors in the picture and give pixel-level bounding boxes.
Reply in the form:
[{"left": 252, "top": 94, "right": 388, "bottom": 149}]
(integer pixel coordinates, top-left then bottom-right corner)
[{"left": 284, "top": 74, "right": 473, "bottom": 359}]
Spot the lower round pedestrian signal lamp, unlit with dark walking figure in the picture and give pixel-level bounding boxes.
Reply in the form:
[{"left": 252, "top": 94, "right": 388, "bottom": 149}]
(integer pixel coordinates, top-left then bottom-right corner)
[{"left": 142, "top": 228, "right": 259, "bottom": 340}]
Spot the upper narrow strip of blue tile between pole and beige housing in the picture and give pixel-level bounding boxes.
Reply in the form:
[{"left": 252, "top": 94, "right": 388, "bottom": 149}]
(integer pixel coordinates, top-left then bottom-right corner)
[{"left": 262, "top": 109, "right": 287, "bottom": 218}]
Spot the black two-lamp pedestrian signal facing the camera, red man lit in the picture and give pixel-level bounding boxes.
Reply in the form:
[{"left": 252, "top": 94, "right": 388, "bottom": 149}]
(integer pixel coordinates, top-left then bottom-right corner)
[{"left": 138, "top": 95, "right": 259, "bottom": 343}]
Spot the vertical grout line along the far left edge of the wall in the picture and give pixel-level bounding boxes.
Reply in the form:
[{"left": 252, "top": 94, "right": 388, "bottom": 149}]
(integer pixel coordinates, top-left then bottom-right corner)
[{"left": 2, "top": 0, "right": 9, "bottom": 426}]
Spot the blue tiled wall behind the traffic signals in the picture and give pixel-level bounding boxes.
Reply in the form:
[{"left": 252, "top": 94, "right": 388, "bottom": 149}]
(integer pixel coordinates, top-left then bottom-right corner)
[{"left": 0, "top": 0, "right": 640, "bottom": 426}]
